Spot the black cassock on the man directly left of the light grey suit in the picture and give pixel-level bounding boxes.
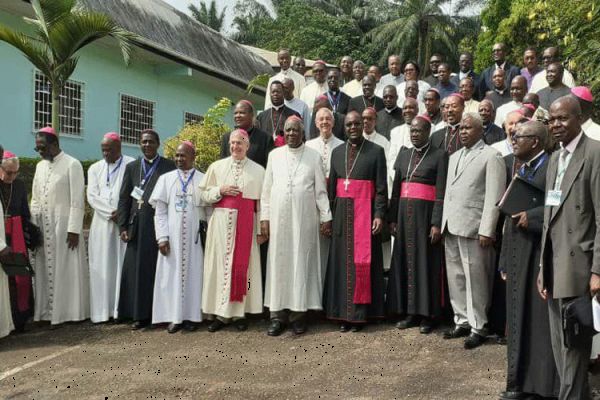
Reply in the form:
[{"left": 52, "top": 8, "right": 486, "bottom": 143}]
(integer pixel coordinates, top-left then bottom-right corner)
[{"left": 386, "top": 144, "right": 448, "bottom": 317}]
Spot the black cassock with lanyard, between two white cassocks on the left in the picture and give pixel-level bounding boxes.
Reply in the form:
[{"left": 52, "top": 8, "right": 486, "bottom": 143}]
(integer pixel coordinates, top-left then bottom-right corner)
[{"left": 118, "top": 157, "right": 175, "bottom": 321}]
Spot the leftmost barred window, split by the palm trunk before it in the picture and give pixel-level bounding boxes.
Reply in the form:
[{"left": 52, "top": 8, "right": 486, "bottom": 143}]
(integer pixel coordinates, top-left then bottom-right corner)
[{"left": 33, "top": 71, "right": 83, "bottom": 136}]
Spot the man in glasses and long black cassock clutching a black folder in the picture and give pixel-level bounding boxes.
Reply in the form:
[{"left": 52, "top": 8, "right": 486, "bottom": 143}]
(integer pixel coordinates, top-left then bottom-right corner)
[{"left": 499, "top": 121, "right": 559, "bottom": 399}]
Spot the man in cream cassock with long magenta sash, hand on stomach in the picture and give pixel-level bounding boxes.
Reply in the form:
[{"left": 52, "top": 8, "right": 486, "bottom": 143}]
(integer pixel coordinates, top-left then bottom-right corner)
[{"left": 200, "top": 129, "right": 265, "bottom": 332}]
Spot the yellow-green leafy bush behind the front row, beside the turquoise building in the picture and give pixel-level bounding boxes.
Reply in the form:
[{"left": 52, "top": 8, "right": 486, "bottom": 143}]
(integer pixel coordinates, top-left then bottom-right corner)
[{"left": 164, "top": 97, "right": 233, "bottom": 171}]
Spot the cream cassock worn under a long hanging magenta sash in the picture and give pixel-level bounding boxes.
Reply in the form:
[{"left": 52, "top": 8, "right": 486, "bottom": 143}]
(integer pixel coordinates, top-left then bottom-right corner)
[{"left": 200, "top": 157, "right": 265, "bottom": 318}]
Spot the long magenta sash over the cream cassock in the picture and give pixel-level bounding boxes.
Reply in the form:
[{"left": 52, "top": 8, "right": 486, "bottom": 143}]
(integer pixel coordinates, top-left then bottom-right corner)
[{"left": 214, "top": 193, "right": 256, "bottom": 302}]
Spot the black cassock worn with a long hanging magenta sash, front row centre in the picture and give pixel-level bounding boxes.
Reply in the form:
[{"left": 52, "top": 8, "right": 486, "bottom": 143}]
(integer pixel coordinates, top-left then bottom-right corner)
[{"left": 323, "top": 140, "right": 387, "bottom": 322}]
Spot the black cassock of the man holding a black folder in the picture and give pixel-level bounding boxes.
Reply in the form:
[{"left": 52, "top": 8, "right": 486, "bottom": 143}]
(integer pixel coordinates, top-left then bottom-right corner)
[{"left": 500, "top": 154, "right": 559, "bottom": 397}]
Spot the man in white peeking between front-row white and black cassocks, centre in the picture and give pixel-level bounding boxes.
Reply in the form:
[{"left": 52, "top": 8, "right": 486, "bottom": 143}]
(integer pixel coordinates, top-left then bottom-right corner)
[{"left": 306, "top": 108, "right": 344, "bottom": 281}]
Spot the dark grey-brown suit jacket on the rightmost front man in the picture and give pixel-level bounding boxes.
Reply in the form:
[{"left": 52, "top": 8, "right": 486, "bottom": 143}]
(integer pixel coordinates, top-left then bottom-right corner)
[{"left": 538, "top": 131, "right": 600, "bottom": 299}]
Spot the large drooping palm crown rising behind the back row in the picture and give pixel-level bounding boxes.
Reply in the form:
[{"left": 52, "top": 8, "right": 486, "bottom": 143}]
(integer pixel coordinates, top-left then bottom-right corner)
[{"left": 367, "top": 0, "right": 456, "bottom": 66}]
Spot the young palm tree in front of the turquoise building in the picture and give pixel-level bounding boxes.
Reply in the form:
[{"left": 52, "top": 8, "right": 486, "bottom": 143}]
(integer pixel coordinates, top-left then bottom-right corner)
[{"left": 0, "top": 0, "right": 137, "bottom": 132}]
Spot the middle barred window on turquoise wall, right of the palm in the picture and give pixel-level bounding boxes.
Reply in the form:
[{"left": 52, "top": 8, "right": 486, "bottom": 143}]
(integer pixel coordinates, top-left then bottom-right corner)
[{"left": 120, "top": 94, "right": 155, "bottom": 144}]
